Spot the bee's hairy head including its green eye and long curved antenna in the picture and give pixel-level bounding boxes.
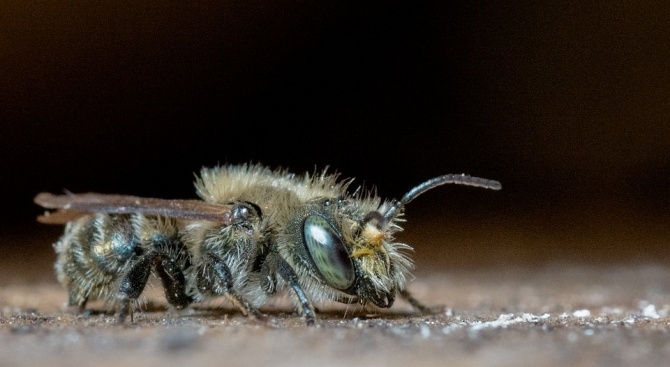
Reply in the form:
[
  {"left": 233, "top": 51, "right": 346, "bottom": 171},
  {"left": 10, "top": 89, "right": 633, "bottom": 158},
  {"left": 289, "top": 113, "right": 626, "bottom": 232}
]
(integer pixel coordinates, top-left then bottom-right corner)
[{"left": 300, "top": 175, "right": 500, "bottom": 308}]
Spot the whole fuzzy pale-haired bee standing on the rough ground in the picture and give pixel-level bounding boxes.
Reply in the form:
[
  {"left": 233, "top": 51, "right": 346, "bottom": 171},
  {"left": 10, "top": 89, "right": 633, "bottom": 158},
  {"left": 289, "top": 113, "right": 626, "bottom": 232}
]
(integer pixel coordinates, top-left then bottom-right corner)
[{"left": 35, "top": 163, "right": 501, "bottom": 325}]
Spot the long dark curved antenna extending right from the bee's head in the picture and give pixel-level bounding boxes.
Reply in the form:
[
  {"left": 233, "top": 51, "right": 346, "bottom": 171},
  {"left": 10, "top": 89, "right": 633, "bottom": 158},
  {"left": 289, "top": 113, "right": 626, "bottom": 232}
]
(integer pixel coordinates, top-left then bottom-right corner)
[{"left": 380, "top": 174, "right": 502, "bottom": 226}]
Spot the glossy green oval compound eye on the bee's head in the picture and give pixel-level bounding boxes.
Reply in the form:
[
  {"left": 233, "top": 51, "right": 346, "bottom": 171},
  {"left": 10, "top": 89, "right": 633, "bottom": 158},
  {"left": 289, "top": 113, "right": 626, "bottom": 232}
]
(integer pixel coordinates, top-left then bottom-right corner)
[{"left": 303, "top": 215, "right": 356, "bottom": 290}]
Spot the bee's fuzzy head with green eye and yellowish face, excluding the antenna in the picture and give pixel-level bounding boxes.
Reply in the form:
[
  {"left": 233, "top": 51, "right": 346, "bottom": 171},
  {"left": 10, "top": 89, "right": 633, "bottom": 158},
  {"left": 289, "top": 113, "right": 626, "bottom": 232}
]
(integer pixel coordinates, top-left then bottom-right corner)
[{"left": 281, "top": 198, "right": 412, "bottom": 308}]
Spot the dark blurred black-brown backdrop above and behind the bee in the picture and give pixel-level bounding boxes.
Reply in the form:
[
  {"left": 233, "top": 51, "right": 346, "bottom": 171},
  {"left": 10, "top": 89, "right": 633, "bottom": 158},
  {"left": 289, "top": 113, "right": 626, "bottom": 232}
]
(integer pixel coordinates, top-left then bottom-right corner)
[{"left": 0, "top": 0, "right": 670, "bottom": 276}]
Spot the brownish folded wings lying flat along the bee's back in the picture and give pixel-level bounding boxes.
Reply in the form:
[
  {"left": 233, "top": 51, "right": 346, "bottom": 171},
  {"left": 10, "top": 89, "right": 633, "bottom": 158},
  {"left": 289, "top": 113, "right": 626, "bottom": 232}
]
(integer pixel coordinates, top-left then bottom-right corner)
[{"left": 34, "top": 192, "right": 232, "bottom": 225}]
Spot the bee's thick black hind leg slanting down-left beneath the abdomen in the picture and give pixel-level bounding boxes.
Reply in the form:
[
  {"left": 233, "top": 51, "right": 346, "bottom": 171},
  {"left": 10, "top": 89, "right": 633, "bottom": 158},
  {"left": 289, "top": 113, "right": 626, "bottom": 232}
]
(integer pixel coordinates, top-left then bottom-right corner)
[{"left": 116, "top": 253, "right": 155, "bottom": 324}]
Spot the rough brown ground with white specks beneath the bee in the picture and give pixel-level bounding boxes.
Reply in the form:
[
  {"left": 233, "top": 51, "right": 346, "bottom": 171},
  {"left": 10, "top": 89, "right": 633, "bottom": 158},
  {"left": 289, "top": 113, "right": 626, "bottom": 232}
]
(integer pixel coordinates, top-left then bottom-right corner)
[{"left": 0, "top": 217, "right": 670, "bottom": 367}]
